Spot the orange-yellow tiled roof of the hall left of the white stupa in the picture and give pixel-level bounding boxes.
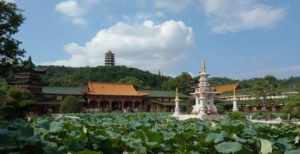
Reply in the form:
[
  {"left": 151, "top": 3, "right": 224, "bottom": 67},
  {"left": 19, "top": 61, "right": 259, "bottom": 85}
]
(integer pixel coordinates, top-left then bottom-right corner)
[{"left": 87, "top": 82, "right": 146, "bottom": 96}]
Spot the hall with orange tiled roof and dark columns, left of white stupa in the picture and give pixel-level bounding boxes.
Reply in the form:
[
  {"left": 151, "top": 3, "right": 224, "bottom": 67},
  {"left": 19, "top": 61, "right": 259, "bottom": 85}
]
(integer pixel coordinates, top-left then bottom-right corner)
[{"left": 85, "top": 82, "right": 146, "bottom": 112}]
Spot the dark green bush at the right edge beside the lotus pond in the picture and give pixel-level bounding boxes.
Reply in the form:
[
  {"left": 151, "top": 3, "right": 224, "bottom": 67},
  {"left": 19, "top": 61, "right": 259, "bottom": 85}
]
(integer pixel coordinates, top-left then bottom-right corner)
[{"left": 283, "top": 95, "right": 300, "bottom": 118}]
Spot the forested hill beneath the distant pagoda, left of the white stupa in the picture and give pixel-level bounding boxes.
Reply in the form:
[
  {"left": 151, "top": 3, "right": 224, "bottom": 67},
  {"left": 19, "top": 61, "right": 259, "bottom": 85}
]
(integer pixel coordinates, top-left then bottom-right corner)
[{"left": 40, "top": 66, "right": 170, "bottom": 89}]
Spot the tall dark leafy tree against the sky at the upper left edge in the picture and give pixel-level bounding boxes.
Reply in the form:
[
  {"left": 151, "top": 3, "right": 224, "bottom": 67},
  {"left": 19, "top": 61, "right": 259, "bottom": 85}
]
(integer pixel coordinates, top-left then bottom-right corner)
[{"left": 0, "top": 1, "right": 25, "bottom": 78}]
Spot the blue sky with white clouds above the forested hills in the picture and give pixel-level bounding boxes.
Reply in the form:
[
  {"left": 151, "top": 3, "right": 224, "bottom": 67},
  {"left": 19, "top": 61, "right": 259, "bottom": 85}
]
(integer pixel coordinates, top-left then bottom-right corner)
[{"left": 10, "top": 0, "right": 300, "bottom": 79}]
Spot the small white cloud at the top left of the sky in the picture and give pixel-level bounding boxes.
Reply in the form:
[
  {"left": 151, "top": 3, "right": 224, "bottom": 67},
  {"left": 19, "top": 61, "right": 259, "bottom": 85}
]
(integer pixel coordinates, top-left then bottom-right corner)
[{"left": 55, "top": 0, "right": 88, "bottom": 25}]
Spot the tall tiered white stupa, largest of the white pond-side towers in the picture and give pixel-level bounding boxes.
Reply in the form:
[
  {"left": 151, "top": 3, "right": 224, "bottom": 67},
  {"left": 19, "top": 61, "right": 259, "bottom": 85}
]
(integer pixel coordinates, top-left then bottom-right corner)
[{"left": 192, "top": 61, "right": 218, "bottom": 119}]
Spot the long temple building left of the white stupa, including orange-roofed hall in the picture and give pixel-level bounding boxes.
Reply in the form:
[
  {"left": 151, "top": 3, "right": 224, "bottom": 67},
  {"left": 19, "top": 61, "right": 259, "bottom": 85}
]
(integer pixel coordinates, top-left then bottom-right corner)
[{"left": 10, "top": 70, "right": 189, "bottom": 114}]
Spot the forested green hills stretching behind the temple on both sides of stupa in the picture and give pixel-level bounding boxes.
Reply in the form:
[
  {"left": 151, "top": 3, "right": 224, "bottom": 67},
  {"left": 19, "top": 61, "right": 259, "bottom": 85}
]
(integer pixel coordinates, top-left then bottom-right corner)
[{"left": 40, "top": 66, "right": 300, "bottom": 94}]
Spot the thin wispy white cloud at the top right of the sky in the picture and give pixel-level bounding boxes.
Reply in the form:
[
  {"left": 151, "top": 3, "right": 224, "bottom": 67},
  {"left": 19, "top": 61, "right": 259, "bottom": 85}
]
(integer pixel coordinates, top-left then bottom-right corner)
[{"left": 199, "top": 0, "right": 286, "bottom": 33}]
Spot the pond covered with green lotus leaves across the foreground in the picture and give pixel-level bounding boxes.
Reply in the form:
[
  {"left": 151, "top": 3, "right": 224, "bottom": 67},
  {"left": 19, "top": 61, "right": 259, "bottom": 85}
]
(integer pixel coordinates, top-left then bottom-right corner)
[{"left": 0, "top": 113, "right": 300, "bottom": 154}]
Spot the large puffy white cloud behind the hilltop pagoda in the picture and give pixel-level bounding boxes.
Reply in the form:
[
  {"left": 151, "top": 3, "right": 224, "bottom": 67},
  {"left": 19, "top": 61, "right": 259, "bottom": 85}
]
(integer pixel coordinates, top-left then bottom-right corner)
[{"left": 48, "top": 20, "right": 193, "bottom": 70}]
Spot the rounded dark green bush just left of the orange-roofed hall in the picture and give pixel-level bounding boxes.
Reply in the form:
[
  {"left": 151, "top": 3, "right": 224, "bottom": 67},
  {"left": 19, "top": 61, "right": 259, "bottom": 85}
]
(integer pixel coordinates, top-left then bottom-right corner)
[{"left": 59, "top": 96, "right": 81, "bottom": 113}]
